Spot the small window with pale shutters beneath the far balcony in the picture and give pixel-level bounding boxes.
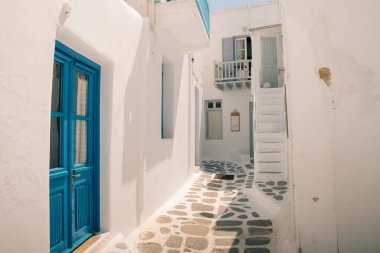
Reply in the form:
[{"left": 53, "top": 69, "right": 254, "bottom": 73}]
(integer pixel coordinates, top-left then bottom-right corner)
[{"left": 206, "top": 100, "right": 223, "bottom": 140}]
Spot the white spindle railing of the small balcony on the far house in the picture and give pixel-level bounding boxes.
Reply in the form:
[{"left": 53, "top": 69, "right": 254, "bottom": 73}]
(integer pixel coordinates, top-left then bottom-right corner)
[{"left": 215, "top": 60, "right": 252, "bottom": 83}]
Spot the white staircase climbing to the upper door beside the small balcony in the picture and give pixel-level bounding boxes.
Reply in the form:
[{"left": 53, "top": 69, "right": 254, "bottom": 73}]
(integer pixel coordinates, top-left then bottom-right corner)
[{"left": 254, "top": 88, "right": 288, "bottom": 184}]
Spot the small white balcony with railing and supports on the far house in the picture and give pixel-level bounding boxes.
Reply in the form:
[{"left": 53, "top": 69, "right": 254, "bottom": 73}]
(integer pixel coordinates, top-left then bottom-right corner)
[{"left": 214, "top": 60, "right": 252, "bottom": 90}]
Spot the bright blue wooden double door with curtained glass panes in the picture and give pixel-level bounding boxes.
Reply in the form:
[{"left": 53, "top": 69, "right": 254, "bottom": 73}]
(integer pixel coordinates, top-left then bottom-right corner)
[{"left": 49, "top": 42, "right": 100, "bottom": 252}]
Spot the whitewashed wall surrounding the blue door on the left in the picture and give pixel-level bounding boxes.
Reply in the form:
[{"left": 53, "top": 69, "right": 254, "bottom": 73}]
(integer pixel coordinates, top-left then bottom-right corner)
[{"left": 0, "top": 0, "right": 194, "bottom": 253}]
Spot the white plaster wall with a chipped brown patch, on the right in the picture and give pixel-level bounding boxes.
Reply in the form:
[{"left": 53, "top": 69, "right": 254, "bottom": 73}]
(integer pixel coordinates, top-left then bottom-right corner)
[{"left": 282, "top": 0, "right": 380, "bottom": 253}]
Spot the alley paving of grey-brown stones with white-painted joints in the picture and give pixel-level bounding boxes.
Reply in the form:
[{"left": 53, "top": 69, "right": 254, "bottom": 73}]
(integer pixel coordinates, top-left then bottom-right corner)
[{"left": 106, "top": 161, "right": 273, "bottom": 253}]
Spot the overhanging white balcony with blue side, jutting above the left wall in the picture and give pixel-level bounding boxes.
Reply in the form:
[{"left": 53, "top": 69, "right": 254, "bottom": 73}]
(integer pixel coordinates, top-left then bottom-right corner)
[{"left": 127, "top": 0, "right": 210, "bottom": 50}]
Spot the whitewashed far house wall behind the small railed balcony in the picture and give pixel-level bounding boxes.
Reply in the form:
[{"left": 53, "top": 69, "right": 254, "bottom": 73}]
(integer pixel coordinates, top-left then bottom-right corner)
[{"left": 194, "top": 1, "right": 280, "bottom": 162}]
